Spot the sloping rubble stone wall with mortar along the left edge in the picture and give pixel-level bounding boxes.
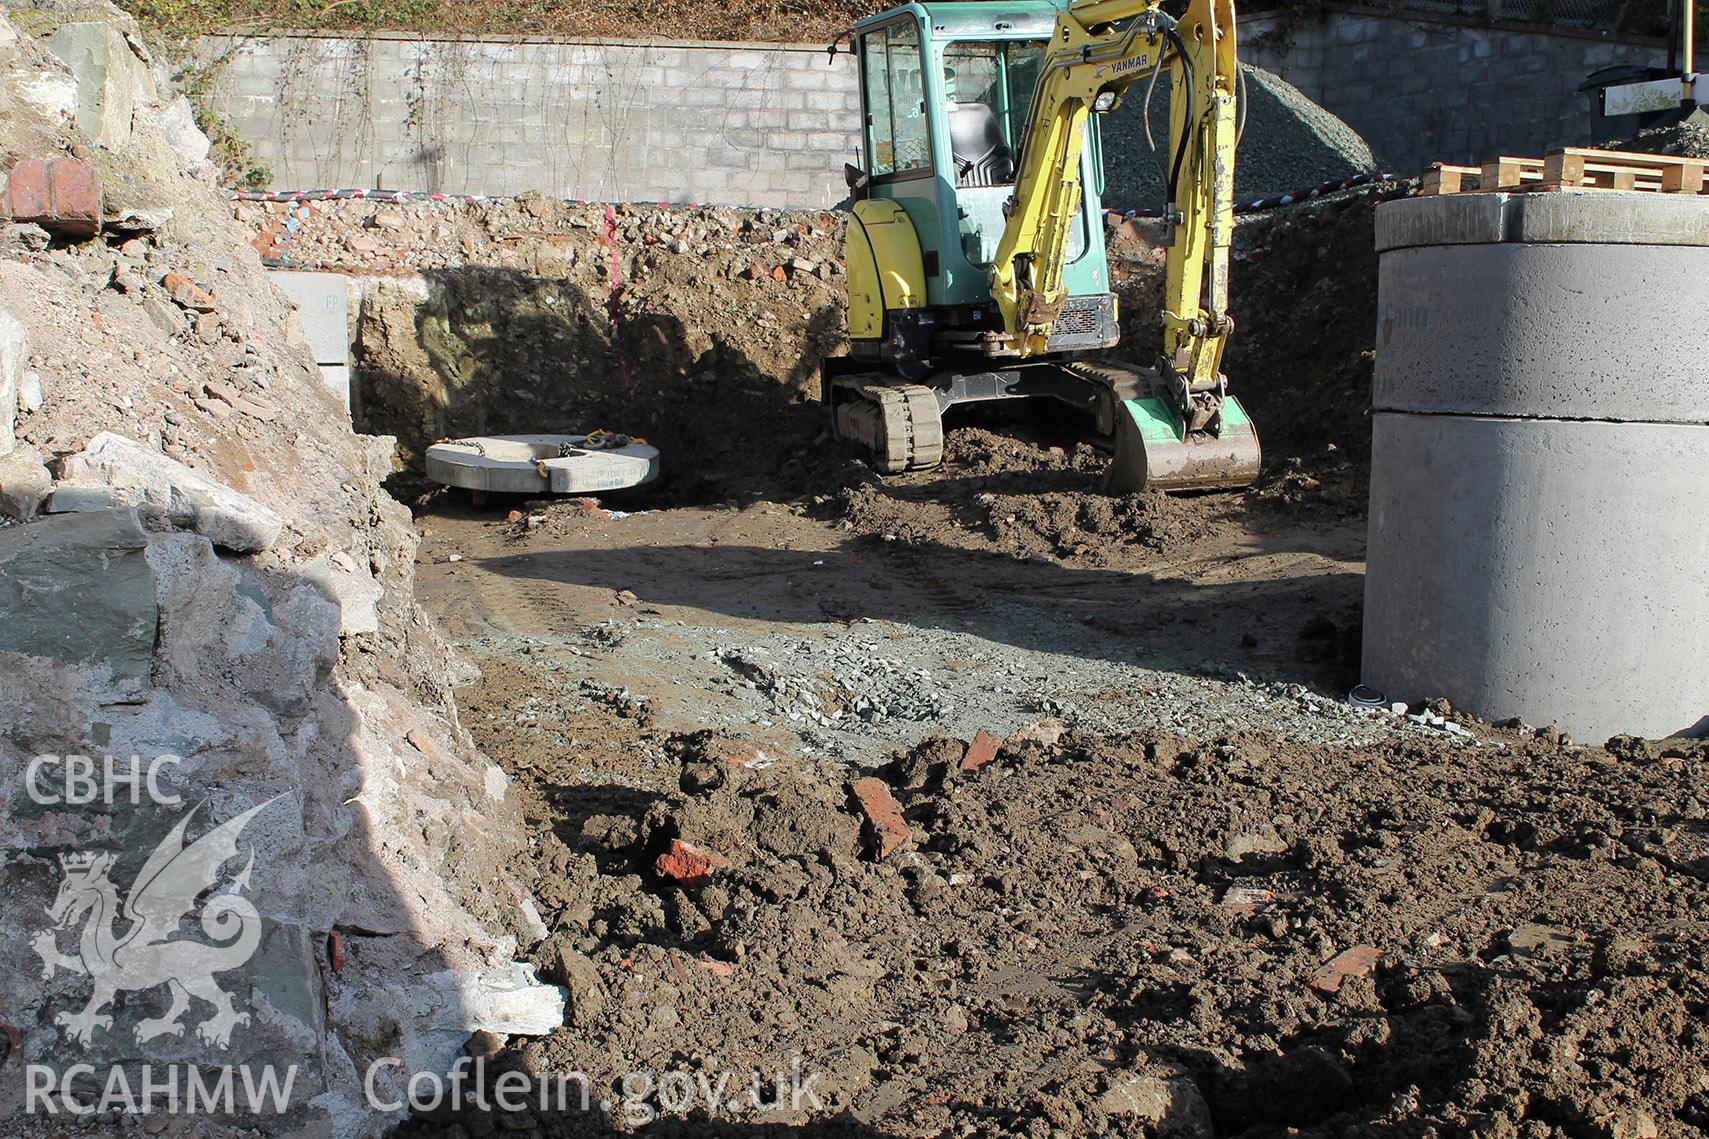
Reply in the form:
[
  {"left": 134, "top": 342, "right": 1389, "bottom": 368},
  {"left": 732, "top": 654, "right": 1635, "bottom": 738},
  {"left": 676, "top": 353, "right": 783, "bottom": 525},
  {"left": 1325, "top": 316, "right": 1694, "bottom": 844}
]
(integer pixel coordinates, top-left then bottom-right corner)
[{"left": 0, "top": 3, "right": 564, "bottom": 1137}]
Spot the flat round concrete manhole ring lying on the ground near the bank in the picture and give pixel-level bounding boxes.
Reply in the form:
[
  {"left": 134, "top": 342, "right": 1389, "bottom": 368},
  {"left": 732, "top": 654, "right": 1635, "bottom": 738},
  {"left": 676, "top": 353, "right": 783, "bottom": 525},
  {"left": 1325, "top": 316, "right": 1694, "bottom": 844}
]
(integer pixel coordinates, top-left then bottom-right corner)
[{"left": 427, "top": 434, "right": 658, "bottom": 494}]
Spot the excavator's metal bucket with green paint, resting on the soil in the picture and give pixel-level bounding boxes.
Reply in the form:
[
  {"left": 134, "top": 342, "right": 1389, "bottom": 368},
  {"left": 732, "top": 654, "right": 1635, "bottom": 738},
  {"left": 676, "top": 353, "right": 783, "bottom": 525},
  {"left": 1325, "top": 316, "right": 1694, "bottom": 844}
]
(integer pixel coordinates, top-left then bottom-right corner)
[{"left": 1104, "top": 395, "right": 1263, "bottom": 494}]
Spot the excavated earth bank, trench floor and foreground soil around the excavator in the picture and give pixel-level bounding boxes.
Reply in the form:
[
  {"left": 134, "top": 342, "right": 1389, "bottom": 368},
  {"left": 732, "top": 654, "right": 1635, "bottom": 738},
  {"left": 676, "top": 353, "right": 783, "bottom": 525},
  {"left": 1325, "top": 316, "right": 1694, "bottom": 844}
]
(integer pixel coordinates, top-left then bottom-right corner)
[{"left": 247, "top": 197, "right": 1709, "bottom": 1137}]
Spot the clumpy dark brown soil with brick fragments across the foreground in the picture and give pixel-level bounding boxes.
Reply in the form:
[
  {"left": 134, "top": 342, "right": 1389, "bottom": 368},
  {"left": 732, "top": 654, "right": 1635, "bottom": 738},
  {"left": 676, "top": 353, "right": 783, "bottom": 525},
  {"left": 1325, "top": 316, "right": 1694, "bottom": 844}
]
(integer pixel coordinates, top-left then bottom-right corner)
[{"left": 393, "top": 696, "right": 1709, "bottom": 1137}]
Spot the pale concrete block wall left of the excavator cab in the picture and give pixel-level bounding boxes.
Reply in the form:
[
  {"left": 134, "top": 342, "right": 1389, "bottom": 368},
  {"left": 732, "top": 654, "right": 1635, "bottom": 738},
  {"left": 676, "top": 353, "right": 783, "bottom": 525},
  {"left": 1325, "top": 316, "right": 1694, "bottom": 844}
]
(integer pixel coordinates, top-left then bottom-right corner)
[{"left": 203, "top": 36, "right": 860, "bottom": 207}]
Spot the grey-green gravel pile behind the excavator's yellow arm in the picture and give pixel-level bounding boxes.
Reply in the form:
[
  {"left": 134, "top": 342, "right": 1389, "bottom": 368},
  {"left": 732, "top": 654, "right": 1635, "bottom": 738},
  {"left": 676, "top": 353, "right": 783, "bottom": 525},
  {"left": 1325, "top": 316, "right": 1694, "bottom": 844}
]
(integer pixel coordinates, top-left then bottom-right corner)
[{"left": 1104, "top": 67, "right": 1377, "bottom": 210}]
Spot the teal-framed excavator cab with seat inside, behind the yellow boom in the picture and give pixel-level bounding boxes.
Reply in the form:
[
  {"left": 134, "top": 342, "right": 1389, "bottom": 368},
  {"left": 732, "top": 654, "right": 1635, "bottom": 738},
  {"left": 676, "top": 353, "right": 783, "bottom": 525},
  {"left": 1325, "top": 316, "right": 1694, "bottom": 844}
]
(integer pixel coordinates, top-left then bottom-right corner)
[{"left": 849, "top": 0, "right": 1119, "bottom": 364}]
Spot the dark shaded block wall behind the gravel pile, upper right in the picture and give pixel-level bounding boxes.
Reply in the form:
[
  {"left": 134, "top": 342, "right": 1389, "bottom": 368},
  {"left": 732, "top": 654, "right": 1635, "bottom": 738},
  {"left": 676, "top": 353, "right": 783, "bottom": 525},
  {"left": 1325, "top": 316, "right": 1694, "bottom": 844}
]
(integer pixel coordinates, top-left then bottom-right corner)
[{"left": 1241, "top": 7, "right": 1666, "bottom": 174}]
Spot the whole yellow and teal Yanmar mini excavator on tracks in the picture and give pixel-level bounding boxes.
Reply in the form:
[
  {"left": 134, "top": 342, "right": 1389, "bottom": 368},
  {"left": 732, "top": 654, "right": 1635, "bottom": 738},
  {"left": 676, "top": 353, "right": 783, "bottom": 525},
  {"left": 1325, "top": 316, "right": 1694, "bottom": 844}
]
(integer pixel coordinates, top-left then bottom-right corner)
[{"left": 822, "top": 0, "right": 1261, "bottom": 493}]
